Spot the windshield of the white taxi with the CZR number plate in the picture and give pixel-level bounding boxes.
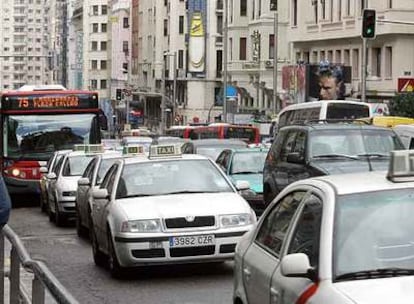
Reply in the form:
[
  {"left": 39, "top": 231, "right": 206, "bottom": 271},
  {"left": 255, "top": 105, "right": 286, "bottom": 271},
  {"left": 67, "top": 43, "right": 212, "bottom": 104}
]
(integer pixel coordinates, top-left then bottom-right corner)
[{"left": 116, "top": 159, "right": 233, "bottom": 198}]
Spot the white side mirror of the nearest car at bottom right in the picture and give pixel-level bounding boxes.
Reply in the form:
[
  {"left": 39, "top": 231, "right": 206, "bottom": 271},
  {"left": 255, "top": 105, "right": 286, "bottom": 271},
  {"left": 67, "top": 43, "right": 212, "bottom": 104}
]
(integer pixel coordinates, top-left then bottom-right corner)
[{"left": 280, "top": 253, "right": 317, "bottom": 281}]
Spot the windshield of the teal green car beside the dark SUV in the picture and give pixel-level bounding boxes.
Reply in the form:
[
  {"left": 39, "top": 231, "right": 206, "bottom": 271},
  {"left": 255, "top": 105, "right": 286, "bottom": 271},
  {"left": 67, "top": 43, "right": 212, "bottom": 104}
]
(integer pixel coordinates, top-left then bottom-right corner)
[{"left": 230, "top": 151, "right": 267, "bottom": 174}]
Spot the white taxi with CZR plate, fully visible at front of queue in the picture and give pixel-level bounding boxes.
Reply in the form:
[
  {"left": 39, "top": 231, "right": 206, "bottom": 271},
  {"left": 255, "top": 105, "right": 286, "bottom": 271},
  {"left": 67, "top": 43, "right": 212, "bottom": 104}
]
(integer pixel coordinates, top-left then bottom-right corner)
[{"left": 90, "top": 145, "right": 256, "bottom": 276}]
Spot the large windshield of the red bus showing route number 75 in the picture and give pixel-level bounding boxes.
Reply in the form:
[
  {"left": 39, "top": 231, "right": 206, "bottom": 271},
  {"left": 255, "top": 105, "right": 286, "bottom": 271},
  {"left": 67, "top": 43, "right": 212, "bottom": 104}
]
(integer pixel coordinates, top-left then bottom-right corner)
[{"left": 3, "top": 114, "right": 97, "bottom": 160}]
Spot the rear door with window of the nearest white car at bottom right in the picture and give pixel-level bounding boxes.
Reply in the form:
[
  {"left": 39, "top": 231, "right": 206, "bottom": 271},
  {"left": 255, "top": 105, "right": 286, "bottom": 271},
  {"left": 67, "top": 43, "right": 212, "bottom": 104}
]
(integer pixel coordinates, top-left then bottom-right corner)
[{"left": 242, "top": 191, "right": 306, "bottom": 304}]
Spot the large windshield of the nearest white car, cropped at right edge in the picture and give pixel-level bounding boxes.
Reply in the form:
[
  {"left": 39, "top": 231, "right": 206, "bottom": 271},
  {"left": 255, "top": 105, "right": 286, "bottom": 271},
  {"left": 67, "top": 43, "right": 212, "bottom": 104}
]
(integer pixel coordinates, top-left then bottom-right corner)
[{"left": 333, "top": 189, "right": 414, "bottom": 278}]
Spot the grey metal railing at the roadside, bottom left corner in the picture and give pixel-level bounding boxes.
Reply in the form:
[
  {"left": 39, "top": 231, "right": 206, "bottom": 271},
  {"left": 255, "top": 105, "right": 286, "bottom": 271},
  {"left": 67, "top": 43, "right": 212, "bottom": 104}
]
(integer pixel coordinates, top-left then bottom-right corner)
[{"left": 0, "top": 225, "right": 79, "bottom": 304}]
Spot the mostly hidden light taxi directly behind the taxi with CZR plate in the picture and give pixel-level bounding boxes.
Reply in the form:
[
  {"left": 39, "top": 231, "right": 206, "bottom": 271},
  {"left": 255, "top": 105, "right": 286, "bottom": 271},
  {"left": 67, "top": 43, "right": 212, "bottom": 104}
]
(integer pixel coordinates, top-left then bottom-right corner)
[{"left": 76, "top": 150, "right": 122, "bottom": 236}]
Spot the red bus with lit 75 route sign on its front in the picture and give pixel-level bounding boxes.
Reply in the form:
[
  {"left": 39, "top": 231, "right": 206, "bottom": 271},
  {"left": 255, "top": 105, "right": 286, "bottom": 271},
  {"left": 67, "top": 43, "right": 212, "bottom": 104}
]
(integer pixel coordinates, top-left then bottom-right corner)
[{"left": 0, "top": 89, "right": 105, "bottom": 203}]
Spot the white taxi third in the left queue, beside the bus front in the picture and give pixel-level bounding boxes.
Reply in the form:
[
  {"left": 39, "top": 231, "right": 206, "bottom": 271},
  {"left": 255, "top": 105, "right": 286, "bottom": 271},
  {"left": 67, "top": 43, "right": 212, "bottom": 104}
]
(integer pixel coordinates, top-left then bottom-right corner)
[{"left": 47, "top": 145, "right": 103, "bottom": 226}]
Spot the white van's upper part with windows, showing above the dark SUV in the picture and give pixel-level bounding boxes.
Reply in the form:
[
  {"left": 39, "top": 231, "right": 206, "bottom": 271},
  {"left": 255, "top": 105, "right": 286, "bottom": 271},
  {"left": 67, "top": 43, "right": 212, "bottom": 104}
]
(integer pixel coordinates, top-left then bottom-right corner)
[{"left": 276, "top": 100, "right": 371, "bottom": 129}]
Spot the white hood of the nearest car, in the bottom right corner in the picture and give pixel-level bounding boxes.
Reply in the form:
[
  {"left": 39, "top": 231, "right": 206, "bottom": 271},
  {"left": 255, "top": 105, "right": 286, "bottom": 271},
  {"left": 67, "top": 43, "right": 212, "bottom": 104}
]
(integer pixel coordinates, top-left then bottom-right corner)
[{"left": 334, "top": 276, "right": 414, "bottom": 304}]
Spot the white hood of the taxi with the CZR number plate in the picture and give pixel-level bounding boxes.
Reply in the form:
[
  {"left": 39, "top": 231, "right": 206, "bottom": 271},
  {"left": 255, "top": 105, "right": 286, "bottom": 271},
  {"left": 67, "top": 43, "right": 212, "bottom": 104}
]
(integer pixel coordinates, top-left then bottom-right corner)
[{"left": 118, "top": 192, "right": 251, "bottom": 220}]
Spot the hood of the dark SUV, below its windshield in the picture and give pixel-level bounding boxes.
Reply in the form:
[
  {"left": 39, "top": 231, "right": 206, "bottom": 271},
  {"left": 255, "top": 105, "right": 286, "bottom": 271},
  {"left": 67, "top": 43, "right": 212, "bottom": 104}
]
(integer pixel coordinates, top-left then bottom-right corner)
[{"left": 310, "top": 158, "right": 389, "bottom": 175}]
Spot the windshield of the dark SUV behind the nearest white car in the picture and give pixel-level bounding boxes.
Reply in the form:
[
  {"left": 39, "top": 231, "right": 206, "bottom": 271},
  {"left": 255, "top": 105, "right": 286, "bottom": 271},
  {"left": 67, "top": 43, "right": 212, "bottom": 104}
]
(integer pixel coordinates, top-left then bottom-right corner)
[{"left": 310, "top": 129, "right": 404, "bottom": 157}]
